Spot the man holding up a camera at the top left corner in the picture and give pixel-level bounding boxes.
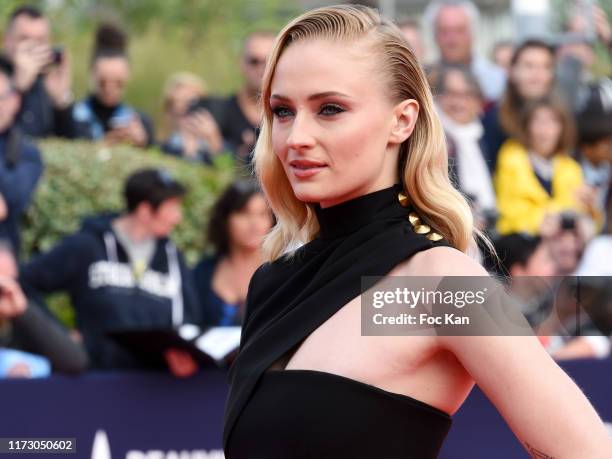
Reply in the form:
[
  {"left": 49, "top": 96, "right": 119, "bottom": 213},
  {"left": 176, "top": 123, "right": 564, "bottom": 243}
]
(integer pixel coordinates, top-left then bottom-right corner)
[{"left": 3, "top": 6, "right": 72, "bottom": 137}]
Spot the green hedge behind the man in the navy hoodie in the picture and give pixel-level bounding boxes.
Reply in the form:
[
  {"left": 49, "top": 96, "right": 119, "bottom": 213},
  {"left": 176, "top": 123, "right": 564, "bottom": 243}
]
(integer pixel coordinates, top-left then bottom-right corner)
[{"left": 22, "top": 140, "right": 234, "bottom": 325}]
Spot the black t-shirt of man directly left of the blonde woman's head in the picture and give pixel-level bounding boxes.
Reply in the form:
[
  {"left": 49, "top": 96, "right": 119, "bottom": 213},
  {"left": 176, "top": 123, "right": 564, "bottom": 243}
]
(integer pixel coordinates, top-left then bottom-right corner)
[{"left": 207, "top": 94, "right": 257, "bottom": 159}]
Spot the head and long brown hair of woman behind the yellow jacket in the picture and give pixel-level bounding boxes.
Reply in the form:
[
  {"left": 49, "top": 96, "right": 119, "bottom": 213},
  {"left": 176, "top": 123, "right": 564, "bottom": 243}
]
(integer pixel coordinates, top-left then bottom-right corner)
[{"left": 482, "top": 40, "right": 555, "bottom": 172}]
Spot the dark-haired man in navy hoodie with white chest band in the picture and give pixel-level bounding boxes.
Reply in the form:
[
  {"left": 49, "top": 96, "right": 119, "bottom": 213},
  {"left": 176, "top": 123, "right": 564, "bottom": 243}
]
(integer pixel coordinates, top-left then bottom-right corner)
[{"left": 20, "top": 169, "right": 199, "bottom": 369}]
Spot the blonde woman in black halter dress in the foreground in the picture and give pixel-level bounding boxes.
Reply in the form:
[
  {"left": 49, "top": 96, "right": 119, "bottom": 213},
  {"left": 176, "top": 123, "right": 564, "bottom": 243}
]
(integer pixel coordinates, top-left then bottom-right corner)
[{"left": 223, "top": 6, "right": 610, "bottom": 459}]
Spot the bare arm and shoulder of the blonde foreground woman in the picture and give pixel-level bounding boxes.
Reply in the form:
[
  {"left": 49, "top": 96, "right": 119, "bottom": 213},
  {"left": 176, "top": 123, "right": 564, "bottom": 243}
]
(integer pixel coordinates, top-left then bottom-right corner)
[{"left": 411, "top": 247, "right": 612, "bottom": 459}]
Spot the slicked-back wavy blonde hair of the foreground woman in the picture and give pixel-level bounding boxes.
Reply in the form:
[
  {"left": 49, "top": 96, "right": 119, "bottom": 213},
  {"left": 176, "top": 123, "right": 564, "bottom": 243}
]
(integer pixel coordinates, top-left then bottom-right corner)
[{"left": 254, "top": 5, "right": 473, "bottom": 260}]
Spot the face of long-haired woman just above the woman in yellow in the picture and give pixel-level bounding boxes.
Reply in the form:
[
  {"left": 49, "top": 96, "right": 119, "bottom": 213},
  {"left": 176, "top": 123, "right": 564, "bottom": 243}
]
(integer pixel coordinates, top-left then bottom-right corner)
[{"left": 510, "top": 48, "right": 555, "bottom": 100}]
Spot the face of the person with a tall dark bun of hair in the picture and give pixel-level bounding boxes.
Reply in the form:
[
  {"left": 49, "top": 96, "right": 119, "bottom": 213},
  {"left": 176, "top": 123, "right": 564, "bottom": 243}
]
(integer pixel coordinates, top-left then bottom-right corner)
[{"left": 92, "top": 57, "right": 130, "bottom": 107}]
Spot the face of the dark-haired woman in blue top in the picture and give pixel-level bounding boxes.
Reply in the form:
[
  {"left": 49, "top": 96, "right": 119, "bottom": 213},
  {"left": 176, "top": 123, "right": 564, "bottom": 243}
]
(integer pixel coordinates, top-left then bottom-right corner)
[{"left": 228, "top": 193, "right": 272, "bottom": 250}]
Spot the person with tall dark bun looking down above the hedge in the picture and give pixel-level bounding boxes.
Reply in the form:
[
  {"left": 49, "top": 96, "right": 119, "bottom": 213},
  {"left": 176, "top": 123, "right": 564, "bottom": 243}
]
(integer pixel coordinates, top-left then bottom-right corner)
[{"left": 71, "top": 25, "right": 154, "bottom": 147}]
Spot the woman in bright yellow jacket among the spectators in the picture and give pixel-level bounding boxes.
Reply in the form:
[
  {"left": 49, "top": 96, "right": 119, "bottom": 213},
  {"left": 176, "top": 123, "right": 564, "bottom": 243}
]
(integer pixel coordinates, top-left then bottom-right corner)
[{"left": 494, "top": 98, "right": 591, "bottom": 234}]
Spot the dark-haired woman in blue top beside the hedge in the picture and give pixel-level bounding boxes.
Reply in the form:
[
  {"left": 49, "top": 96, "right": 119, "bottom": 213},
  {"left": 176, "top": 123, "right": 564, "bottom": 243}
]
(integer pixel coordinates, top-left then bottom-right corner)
[{"left": 193, "top": 179, "right": 273, "bottom": 325}]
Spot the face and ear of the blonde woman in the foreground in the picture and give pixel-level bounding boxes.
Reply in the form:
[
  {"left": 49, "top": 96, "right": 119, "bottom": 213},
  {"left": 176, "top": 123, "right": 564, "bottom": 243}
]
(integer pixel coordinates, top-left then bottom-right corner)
[{"left": 269, "top": 40, "right": 418, "bottom": 207}]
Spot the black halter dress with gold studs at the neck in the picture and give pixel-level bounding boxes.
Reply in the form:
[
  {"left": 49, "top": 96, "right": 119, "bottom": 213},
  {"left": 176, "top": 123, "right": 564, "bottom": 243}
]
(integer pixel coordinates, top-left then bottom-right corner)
[{"left": 223, "top": 185, "right": 452, "bottom": 459}]
